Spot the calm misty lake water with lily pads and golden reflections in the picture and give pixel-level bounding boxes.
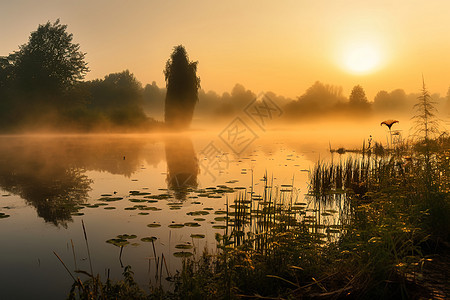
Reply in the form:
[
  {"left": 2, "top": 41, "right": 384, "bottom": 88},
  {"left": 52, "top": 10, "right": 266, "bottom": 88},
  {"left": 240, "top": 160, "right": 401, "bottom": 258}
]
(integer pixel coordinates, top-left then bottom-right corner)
[{"left": 0, "top": 124, "right": 386, "bottom": 299}]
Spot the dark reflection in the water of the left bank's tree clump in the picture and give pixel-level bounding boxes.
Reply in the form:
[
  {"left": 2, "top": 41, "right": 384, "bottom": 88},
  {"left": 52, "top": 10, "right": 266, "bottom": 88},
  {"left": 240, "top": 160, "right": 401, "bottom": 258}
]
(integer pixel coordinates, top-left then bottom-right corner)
[{"left": 0, "top": 136, "right": 163, "bottom": 226}]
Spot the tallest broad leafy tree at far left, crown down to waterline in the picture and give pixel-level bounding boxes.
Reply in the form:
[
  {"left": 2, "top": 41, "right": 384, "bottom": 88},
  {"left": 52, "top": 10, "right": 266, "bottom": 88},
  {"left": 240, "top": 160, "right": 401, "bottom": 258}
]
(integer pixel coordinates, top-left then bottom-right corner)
[{"left": 0, "top": 20, "right": 88, "bottom": 129}]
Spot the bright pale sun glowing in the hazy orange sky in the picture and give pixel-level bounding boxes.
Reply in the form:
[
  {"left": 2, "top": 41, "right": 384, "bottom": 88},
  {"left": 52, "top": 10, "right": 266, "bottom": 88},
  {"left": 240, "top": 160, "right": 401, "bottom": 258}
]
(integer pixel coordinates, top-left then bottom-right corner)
[{"left": 340, "top": 41, "right": 382, "bottom": 74}]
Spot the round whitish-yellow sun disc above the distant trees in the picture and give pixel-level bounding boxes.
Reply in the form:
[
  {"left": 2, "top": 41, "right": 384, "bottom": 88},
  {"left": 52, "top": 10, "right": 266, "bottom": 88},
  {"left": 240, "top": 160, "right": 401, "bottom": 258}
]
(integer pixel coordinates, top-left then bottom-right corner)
[{"left": 343, "top": 44, "right": 381, "bottom": 73}]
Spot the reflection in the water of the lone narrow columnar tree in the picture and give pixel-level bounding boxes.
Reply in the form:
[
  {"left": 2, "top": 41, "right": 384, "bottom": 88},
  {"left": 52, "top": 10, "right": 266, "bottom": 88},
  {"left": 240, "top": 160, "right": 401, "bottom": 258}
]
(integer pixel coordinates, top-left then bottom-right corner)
[{"left": 166, "top": 136, "right": 199, "bottom": 200}]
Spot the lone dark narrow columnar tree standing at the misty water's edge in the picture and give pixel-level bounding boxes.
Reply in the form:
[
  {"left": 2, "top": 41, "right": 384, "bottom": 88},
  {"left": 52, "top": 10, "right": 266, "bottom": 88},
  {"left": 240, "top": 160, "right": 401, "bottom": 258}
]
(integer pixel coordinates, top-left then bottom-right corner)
[{"left": 164, "top": 45, "right": 200, "bottom": 129}]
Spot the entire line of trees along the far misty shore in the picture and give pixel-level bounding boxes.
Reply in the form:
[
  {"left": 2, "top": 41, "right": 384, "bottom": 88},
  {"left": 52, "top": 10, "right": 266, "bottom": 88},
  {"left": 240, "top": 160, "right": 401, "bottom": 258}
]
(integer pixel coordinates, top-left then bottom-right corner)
[{"left": 0, "top": 20, "right": 450, "bottom": 132}]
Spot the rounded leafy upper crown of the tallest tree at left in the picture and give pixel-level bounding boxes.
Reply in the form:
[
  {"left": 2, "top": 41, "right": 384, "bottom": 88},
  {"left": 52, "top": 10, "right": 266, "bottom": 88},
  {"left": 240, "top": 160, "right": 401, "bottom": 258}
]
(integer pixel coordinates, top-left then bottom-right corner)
[{"left": 10, "top": 19, "right": 89, "bottom": 94}]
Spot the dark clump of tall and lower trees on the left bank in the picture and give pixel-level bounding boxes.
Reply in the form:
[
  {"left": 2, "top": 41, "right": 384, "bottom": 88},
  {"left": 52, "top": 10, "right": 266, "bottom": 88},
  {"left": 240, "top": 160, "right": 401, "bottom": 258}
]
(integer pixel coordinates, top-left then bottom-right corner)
[{"left": 0, "top": 20, "right": 158, "bottom": 132}]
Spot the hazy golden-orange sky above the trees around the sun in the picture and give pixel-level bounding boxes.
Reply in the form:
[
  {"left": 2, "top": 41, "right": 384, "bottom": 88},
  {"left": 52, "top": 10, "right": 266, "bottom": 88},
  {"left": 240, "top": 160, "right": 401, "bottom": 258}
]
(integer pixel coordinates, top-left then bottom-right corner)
[{"left": 0, "top": 0, "right": 450, "bottom": 100}]
